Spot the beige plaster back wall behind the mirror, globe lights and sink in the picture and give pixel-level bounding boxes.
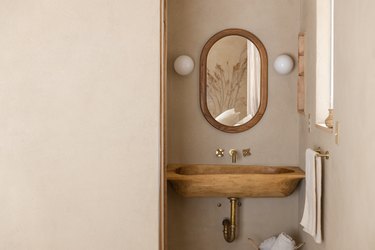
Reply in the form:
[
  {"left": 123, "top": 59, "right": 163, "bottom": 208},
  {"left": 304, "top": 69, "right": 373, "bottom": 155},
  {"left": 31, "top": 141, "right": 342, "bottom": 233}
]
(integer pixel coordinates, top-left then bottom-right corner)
[{"left": 168, "top": 0, "right": 300, "bottom": 250}]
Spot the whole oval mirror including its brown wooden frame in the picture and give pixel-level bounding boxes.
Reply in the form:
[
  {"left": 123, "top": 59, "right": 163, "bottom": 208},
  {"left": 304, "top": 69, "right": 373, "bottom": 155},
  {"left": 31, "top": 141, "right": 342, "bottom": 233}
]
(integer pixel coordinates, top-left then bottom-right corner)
[{"left": 199, "top": 29, "right": 268, "bottom": 133}]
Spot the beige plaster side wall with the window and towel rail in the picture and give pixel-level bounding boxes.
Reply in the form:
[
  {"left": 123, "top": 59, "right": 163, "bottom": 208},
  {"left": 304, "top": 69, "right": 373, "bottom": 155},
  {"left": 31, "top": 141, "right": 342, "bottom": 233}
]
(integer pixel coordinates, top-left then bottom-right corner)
[{"left": 300, "top": 0, "right": 375, "bottom": 250}]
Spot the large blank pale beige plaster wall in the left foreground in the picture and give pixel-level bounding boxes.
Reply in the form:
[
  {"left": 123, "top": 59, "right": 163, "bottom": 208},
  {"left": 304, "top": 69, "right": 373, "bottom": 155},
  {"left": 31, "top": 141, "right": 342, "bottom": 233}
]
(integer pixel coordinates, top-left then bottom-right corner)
[{"left": 0, "top": 0, "right": 160, "bottom": 250}]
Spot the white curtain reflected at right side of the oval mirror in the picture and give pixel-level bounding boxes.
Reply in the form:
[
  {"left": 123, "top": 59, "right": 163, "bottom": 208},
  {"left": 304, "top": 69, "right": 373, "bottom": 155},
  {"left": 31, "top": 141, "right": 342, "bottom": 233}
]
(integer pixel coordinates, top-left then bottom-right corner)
[{"left": 247, "top": 40, "right": 260, "bottom": 120}]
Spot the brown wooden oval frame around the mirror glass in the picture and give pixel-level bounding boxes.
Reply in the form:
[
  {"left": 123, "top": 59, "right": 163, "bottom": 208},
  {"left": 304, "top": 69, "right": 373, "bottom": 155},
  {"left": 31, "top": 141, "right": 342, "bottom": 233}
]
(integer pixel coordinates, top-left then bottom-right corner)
[{"left": 199, "top": 29, "right": 268, "bottom": 133}]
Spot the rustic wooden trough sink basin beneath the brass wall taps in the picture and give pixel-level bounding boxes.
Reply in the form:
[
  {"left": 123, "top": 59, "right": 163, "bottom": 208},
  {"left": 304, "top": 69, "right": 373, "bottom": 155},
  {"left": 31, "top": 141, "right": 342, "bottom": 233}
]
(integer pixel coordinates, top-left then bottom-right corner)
[{"left": 167, "top": 164, "right": 305, "bottom": 198}]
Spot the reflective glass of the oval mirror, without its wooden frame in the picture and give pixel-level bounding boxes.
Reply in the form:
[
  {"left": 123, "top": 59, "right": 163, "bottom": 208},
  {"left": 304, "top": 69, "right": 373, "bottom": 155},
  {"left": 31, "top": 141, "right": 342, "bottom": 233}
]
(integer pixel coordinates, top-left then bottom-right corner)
[{"left": 207, "top": 35, "right": 261, "bottom": 126}]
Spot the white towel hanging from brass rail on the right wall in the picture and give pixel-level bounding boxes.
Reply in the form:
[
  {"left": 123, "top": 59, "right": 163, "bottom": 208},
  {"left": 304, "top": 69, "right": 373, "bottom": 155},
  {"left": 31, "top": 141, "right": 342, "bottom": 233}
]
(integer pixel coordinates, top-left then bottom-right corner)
[{"left": 301, "top": 149, "right": 322, "bottom": 243}]
